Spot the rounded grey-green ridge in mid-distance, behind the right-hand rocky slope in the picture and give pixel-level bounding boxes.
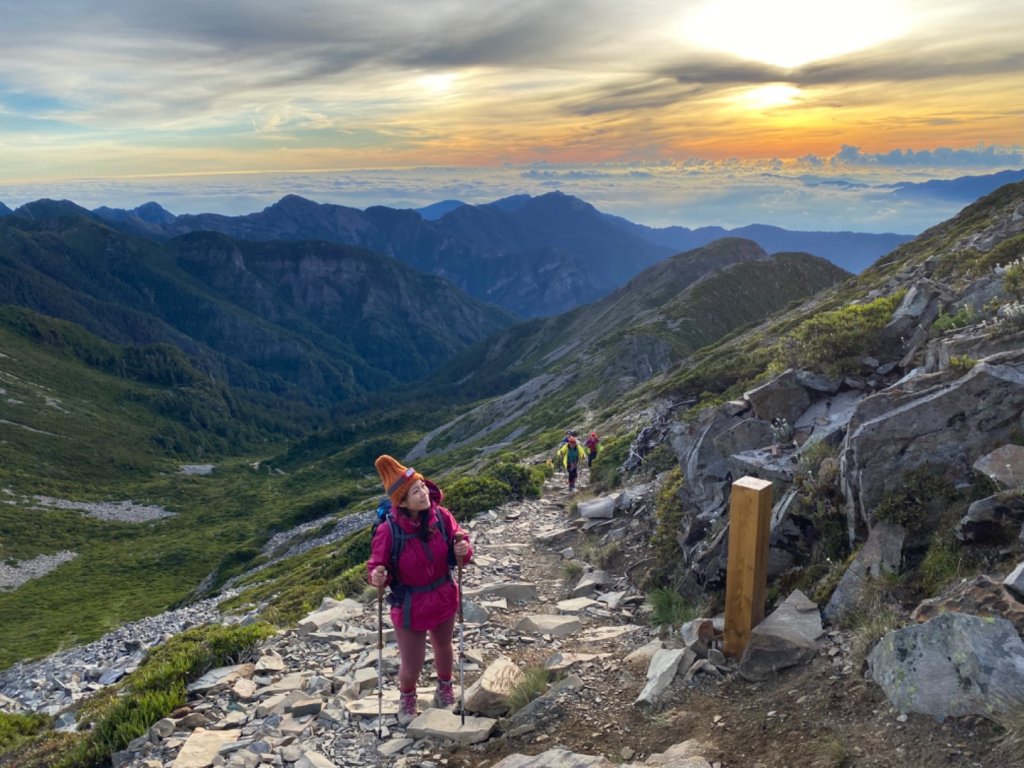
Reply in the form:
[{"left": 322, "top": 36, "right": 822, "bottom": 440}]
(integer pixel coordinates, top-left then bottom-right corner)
[{"left": 413, "top": 239, "right": 847, "bottom": 456}]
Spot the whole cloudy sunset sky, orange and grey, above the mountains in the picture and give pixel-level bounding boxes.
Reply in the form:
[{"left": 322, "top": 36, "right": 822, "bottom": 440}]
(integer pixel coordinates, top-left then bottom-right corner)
[{"left": 0, "top": 0, "right": 1024, "bottom": 233}]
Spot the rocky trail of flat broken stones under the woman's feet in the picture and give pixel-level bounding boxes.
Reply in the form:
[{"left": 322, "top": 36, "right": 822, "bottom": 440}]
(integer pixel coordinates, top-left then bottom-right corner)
[{"left": 0, "top": 469, "right": 1022, "bottom": 768}]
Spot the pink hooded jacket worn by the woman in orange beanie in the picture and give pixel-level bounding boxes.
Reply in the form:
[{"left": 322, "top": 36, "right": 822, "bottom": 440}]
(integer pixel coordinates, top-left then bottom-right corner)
[{"left": 367, "top": 480, "right": 473, "bottom": 632}]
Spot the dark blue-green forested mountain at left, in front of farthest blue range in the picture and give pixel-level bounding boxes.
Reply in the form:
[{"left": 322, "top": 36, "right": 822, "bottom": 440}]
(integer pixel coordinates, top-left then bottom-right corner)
[{"left": 0, "top": 204, "right": 514, "bottom": 404}]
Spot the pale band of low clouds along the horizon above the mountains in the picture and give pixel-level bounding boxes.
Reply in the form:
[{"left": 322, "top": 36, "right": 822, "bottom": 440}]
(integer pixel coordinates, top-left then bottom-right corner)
[{"left": 0, "top": 158, "right": 1024, "bottom": 234}]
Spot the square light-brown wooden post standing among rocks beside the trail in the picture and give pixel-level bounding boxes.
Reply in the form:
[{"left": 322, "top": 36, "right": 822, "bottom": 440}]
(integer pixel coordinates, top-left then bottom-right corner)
[{"left": 722, "top": 477, "right": 771, "bottom": 658}]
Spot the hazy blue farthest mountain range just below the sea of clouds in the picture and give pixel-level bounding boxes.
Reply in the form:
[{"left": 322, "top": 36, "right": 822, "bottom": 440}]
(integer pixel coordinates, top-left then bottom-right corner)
[{"left": 61, "top": 191, "right": 911, "bottom": 317}]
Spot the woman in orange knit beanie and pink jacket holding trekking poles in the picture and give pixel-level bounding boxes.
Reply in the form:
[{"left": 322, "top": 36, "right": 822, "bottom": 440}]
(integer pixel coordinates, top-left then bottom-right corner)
[{"left": 367, "top": 456, "right": 473, "bottom": 725}]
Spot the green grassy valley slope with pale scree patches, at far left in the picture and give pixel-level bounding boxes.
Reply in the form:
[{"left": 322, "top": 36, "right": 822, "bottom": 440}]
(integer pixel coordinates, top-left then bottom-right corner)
[{"left": 0, "top": 306, "right": 327, "bottom": 667}]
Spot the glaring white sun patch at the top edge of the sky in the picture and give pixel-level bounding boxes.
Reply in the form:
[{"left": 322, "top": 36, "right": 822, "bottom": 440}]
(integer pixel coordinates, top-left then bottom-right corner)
[{"left": 680, "top": 0, "right": 909, "bottom": 69}]
